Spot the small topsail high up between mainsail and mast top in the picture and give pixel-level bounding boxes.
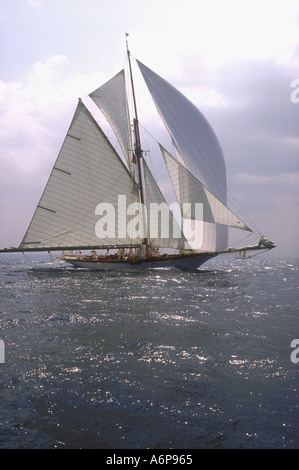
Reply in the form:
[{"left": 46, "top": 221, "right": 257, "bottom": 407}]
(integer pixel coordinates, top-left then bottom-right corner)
[{"left": 89, "top": 70, "right": 132, "bottom": 173}]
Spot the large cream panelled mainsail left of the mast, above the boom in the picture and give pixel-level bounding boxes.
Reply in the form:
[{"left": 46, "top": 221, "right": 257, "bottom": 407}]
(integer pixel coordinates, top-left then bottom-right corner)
[{"left": 20, "top": 101, "right": 139, "bottom": 249}]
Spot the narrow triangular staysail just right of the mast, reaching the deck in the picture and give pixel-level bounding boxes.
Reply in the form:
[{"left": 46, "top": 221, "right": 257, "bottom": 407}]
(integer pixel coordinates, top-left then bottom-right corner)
[{"left": 143, "top": 160, "right": 186, "bottom": 249}]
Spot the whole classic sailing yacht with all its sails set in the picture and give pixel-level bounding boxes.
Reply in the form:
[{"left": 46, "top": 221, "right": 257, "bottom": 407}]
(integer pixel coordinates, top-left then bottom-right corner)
[{"left": 0, "top": 42, "right": 274, "bottom": 270}]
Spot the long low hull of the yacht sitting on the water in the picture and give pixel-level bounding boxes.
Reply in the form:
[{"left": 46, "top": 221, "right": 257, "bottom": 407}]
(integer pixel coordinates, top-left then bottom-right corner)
[{"left": 59, "top": 253, "right": 217, "bottom": 271}]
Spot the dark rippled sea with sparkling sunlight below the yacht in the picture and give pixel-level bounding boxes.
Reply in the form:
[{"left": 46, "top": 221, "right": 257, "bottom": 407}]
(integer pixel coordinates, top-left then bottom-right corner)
[{"left": 0, "top": 256, "right": 299, "bottom": 449}]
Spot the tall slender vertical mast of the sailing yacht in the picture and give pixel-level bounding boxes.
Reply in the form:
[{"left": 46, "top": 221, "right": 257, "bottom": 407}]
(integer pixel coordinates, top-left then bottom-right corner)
[{"left": 126, "top": 33, "right": 149, "bottom": 246}]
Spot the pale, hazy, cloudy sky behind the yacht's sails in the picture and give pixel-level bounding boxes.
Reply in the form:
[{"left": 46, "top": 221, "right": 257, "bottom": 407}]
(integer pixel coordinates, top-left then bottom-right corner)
[{"left": 0, "top": 0, "right": 299, "bottom": 258}]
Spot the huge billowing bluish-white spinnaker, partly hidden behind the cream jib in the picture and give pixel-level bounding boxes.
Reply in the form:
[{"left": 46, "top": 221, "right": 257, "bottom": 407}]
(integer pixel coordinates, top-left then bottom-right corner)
[{"left": 137, "top": 61, "right": 228, "bottom": 251}]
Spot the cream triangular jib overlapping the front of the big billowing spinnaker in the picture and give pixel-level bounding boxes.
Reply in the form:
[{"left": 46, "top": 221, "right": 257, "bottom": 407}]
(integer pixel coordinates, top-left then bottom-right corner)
[{"left": 160, "top": 145, "right": 251, "bottom": 231}]
